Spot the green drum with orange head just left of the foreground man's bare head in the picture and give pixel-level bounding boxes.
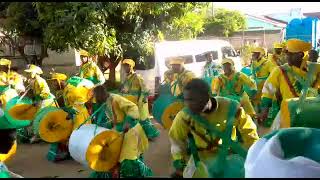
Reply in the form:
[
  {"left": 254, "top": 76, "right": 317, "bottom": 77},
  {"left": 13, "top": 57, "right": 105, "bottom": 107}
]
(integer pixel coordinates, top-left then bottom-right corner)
[{"left": 152, "top": 94, "right": 184, "bottom": 129}]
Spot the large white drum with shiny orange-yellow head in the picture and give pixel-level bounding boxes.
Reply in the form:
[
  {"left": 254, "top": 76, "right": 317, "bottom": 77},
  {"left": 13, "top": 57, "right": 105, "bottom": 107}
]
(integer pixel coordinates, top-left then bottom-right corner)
[{"left": 69, "top": 124, "right": 123, "bottom": 172}]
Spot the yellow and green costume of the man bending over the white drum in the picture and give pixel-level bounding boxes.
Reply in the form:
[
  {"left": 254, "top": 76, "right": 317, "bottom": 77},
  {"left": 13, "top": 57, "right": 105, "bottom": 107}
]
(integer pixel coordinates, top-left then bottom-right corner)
[{"left": 90, "top": 94, "right": 152, "bottom": 178}]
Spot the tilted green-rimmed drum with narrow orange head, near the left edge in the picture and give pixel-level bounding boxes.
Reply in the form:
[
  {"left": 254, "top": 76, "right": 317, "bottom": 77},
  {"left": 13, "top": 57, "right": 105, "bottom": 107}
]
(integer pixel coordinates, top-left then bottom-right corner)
[{"left": 4, "top": 96, "right": 38, "bottom": 126}]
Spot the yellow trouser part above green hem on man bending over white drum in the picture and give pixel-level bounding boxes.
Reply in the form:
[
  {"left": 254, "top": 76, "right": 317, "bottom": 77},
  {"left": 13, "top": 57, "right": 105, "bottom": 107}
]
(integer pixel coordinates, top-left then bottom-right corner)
[{"left": 119, "top": 123, "right": 149, "bottom": 163}]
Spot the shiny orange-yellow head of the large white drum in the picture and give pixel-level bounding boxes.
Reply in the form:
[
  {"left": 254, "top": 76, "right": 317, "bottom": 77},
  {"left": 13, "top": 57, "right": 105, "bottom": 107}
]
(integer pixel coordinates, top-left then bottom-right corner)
[{"left": 86, "top": 130, "right": 123, "bottom": 172}]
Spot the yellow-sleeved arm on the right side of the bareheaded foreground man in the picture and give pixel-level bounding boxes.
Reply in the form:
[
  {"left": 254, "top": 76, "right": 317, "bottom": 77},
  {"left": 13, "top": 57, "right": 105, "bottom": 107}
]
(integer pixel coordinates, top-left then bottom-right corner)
[{"left": 235, "top": 107, "right": 259, "bottom": 149}]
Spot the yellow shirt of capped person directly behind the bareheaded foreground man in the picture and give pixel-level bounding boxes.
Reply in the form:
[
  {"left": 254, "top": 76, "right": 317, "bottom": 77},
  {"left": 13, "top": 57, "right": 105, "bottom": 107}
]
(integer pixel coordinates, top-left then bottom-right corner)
[{"left": 171, "top": 70, "right": 196, "bottom": 96}]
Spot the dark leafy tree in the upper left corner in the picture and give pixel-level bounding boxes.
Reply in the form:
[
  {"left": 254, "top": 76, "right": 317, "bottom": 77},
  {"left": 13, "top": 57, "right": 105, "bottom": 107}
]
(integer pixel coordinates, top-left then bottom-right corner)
[{"left": 0, "top": 2, "right": 48, "bottom": 65}]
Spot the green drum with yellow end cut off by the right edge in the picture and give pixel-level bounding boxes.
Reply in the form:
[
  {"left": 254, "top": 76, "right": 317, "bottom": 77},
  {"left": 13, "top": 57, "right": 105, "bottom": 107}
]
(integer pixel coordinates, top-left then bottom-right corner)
[{"left": 280, "top": 97, "right": 320, "bottom": 128}]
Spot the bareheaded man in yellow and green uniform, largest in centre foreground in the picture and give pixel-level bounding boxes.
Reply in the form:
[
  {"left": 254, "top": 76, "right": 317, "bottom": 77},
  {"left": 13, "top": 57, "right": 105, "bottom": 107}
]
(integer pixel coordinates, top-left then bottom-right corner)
[{"left": 169, "top": 79, "right": 259, "bottom": 178}]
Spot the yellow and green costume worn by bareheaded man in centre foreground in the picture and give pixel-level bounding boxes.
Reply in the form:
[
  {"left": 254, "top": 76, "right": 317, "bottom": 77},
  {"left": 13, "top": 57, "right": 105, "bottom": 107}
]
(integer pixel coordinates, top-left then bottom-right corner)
[{"left": 169, "top": 96, "right": 259, "bottom": 178}]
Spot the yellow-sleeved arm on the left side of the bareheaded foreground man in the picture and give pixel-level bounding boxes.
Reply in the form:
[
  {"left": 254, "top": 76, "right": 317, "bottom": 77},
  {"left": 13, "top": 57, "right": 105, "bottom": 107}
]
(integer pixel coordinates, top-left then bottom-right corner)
[{"left": 169, "top": 111, "right": 190, "bottom": 171}]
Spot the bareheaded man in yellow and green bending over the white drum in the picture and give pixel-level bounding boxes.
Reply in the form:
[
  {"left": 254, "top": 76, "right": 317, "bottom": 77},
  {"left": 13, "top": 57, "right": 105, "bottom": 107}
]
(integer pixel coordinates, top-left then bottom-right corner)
[{"left": 90, "top": 86, "right": 152, "bottom": 178}]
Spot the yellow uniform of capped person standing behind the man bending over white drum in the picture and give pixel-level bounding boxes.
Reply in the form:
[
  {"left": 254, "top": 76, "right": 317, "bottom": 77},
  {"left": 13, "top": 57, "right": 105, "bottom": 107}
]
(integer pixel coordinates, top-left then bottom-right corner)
[{"left": 123, "top": 73, "right": 150, "bottom": 121}]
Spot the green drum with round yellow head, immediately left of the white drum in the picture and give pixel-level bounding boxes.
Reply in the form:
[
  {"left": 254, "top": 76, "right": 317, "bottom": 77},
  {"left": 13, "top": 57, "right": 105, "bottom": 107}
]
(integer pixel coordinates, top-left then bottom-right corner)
[{"left": 33, "top": 106, "right": 73, "bottom": 143}]
